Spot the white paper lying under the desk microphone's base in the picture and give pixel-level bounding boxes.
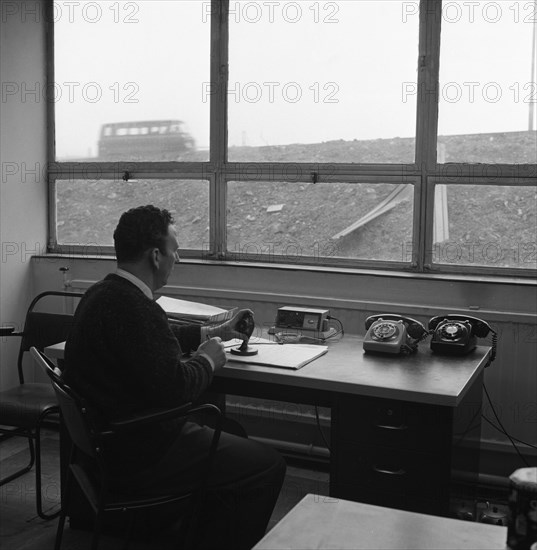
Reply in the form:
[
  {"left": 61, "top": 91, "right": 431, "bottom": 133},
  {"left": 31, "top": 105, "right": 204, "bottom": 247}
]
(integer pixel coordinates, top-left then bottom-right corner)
[{"left": 225, "top": 338, "right": 328, "bottom": 370}]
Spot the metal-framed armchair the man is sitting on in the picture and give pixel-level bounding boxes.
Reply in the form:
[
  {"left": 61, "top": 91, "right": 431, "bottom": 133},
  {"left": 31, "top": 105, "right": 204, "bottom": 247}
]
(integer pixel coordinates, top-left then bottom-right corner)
[{"left": 31, "top": 348, "right": 222, "bottom": 550}]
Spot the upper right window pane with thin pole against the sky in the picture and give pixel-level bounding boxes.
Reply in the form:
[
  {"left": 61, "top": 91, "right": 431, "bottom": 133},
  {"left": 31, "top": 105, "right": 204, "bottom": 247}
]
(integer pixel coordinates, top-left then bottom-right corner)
[{"left": 438, "top": 0, "right": 537, "bottom": 163}]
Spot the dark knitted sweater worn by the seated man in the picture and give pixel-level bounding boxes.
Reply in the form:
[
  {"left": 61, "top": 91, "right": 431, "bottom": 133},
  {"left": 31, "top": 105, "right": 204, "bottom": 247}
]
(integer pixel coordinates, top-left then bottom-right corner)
[{"left": 63, "top": 274, "right": 213, "bottom": 473}]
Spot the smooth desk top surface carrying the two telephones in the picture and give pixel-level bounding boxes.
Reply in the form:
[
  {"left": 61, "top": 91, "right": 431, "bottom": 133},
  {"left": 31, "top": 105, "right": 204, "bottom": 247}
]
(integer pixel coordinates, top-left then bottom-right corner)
[{"left": 45, "top": 335, "right": 490, "bottom": 407}]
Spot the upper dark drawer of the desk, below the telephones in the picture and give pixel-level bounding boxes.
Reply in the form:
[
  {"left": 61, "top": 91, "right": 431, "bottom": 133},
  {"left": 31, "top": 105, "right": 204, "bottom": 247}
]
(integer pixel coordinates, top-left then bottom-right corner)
[{"left": 336, "top": 397, "right": 452, "bottom": 453}]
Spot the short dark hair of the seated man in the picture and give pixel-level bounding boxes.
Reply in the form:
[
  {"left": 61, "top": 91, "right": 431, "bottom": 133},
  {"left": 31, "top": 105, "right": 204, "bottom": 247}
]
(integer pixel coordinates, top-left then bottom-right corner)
[{"left": 114, "top": 204, "right": 174, "bottom": 262}]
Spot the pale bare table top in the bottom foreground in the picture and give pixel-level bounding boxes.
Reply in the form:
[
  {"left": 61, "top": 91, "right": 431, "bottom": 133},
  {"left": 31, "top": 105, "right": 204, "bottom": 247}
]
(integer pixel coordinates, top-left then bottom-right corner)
[{"left": 253, "top": 494, "right": 507, "bottom": 550}]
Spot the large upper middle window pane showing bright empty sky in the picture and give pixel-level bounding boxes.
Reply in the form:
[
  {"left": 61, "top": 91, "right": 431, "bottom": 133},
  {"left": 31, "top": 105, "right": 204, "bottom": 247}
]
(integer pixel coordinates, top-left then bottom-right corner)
[{"left": 228, "top": 0, "right": 418, "bottom": 163}]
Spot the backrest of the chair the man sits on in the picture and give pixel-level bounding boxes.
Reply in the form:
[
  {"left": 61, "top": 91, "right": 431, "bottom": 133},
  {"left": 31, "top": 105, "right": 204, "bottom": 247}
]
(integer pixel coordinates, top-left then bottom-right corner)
[{"left": 30, "top": 347, "right": 96, "bottom": 457}]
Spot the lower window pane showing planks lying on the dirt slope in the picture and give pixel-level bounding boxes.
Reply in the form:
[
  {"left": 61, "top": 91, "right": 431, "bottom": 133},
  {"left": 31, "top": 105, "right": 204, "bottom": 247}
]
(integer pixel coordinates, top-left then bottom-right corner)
[{"left": 227, "top": 182, "right": 414, "bottom": 262}]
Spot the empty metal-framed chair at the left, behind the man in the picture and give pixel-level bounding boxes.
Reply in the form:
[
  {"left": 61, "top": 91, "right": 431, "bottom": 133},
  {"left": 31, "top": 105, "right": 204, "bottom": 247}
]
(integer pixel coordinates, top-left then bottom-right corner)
[{"left": 0, "top": 291, "right": 83, "bottom": 519}]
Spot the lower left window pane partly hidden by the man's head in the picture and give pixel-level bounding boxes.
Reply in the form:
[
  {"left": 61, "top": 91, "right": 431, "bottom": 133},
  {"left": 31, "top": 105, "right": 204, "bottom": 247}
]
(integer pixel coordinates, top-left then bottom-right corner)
[{"left": 56, "top": 180, "right": 209, "bottom": 250}]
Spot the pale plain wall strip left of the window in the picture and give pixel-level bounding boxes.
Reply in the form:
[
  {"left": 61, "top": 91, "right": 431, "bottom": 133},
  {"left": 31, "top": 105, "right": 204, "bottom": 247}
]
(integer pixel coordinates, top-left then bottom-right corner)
[{"left": 0, "top": 1, "right": 47, "bottom": 388}]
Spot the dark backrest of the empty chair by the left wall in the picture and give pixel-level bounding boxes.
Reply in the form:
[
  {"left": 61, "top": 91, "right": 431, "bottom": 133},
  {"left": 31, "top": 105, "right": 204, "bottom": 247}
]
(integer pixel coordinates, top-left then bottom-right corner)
[{"left": 17, "top": 290, "right": 84, "bottom": 384}]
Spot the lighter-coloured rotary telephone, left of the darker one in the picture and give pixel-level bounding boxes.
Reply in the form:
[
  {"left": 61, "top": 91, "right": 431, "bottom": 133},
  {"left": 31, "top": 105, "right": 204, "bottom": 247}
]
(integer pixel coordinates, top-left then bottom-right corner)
[{"left": 364, "top": 313, "right": 429, "bottom": 354}]
